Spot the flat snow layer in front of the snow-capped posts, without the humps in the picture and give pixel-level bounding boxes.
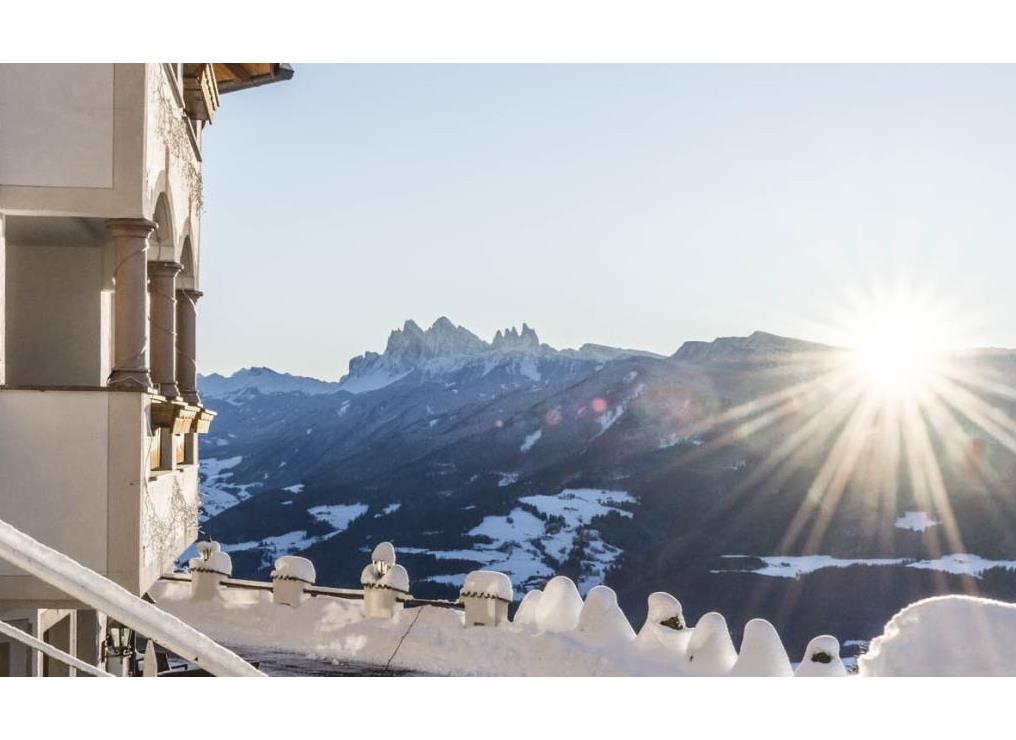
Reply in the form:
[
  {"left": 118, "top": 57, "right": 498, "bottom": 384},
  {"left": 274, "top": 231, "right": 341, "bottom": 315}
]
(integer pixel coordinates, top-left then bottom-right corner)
[{"left": 151, "top": 581, "right": 707, "bottom": 676}]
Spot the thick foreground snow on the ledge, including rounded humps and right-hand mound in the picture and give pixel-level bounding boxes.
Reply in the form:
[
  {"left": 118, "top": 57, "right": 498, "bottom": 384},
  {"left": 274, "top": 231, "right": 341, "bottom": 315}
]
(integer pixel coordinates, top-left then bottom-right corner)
[{"left": 151, "top": 576, "right": 1016, "bottom": 676}]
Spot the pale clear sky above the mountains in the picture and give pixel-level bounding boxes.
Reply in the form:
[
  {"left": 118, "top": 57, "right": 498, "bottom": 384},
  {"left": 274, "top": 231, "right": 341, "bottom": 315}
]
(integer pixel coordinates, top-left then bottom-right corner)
[{"left": 199, "top": 64, "right": 1016, "bottom": 379}]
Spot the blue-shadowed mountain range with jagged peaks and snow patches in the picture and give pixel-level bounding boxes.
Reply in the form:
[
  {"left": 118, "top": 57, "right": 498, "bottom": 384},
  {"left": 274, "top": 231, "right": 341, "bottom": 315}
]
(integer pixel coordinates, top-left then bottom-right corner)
[{"left": 194, "top": 318, "right": 1016, "bottom": 652}]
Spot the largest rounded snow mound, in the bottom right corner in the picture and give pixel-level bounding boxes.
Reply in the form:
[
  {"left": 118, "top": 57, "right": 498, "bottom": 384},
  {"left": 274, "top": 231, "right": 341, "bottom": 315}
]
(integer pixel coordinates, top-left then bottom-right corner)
[{"left": 858, "top": 596, "right": 1016, "bottom": 676}]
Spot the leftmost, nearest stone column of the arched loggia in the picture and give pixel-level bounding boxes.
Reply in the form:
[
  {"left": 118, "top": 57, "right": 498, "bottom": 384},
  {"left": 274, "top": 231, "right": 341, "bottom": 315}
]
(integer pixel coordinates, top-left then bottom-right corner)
[{"left": 106, "top": 219, "right": 155, "bottom": 390}]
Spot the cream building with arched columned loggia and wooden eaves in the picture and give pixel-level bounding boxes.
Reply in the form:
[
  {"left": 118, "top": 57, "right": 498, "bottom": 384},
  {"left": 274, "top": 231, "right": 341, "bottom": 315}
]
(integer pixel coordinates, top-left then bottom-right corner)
[{"left": 0, "top": 63, "right": 293, "bottom": 675}]
